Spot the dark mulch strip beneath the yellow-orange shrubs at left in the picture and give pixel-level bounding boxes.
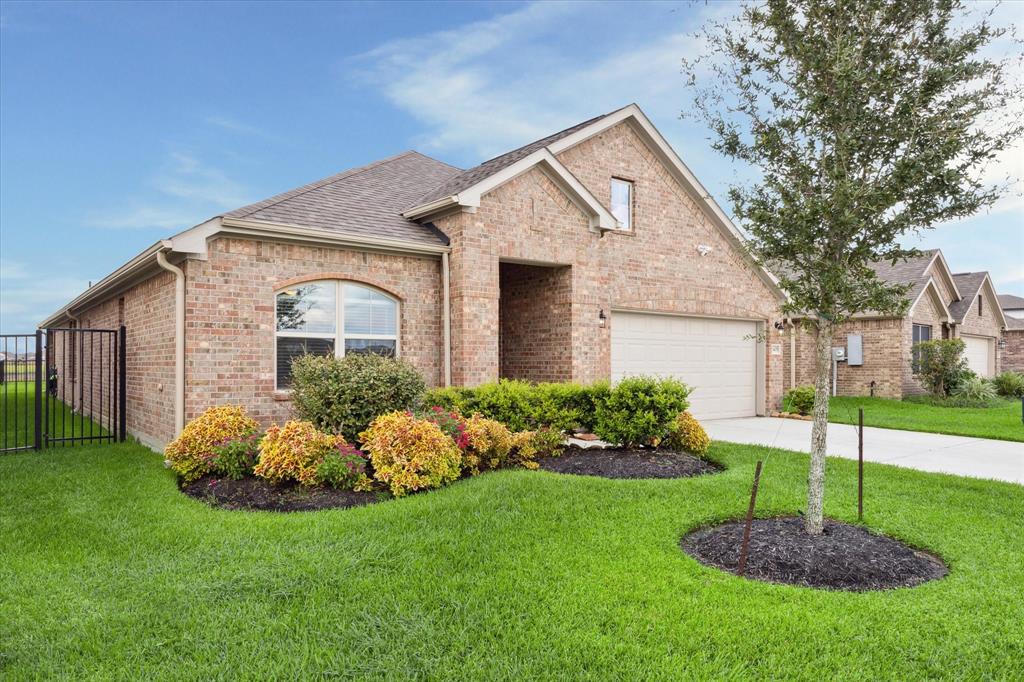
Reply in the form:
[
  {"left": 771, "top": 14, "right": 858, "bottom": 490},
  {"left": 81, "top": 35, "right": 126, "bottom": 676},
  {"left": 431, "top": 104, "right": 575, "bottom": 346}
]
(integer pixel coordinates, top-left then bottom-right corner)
[{"left": 181, "top": 476, "right": 390, "bottom": 511}]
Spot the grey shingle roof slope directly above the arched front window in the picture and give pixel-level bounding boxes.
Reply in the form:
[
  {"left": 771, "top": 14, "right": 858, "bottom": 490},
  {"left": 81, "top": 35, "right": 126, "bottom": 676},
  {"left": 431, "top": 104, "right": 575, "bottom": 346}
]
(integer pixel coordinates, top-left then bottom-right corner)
[{"left": 224, "top": 152, "right": 460, "bottom": 245}]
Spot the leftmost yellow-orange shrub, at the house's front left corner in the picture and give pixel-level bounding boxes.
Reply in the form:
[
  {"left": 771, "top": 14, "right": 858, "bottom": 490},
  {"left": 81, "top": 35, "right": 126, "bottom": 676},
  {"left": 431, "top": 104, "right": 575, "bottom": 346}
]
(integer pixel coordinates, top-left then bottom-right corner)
[{"left": 164, "top": 406, "right": 259, "bottom": 483}]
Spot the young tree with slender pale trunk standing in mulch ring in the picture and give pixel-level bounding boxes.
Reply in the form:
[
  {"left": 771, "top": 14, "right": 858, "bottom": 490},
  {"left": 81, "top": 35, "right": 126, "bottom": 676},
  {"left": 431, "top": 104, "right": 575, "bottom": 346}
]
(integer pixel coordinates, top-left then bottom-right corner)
[{"left": 684, "top": 0, "right": 1022, "bottom": 535}]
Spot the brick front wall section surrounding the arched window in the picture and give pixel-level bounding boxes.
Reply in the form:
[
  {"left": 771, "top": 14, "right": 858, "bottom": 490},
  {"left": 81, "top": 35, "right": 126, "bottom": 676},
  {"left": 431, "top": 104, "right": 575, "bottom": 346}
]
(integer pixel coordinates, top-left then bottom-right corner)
[{"left": 185, "top": 238, "right": 443, "bottom": 425}]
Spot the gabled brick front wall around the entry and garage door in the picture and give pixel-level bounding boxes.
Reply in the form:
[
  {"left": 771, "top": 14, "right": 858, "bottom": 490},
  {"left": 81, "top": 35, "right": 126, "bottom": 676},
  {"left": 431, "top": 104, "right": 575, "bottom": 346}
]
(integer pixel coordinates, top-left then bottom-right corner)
[{"left": 435, "top": 119, "right": 784, "bottom": 406}]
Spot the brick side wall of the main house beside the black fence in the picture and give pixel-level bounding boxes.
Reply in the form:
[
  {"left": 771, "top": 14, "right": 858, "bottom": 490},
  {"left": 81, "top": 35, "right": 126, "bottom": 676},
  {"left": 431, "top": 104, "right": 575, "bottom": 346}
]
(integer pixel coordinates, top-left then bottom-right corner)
[{"left": 63, "top": 264, "right": 178, "bottom": 447}]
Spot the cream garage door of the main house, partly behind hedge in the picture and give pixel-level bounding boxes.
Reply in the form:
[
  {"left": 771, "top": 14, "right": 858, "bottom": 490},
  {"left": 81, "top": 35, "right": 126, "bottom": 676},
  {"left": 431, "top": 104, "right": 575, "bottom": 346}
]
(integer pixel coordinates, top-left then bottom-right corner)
[{"left": 611, "top": 312, "right": 758, "bottom": 419}]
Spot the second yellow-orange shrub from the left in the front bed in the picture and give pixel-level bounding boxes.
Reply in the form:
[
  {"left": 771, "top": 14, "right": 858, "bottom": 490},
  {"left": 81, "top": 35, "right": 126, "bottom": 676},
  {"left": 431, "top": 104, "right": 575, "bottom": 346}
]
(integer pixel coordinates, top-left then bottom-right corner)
[{"left": 253, "top": 420, "right": 346, "bottom": 485}]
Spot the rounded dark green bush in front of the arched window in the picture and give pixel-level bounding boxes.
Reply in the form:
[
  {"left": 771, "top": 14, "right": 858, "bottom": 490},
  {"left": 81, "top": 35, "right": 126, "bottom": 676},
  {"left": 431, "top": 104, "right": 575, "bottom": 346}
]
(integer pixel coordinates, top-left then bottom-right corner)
[{"left": 292, "top": 353, "right": 425, "bottom": 442}]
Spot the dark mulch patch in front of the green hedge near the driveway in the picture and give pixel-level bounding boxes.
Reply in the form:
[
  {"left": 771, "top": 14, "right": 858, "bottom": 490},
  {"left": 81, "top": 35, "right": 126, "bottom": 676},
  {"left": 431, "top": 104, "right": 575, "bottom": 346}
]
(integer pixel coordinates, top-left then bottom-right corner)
[{"left": 540, "top": 447, "right": 722, "bottom": 478}]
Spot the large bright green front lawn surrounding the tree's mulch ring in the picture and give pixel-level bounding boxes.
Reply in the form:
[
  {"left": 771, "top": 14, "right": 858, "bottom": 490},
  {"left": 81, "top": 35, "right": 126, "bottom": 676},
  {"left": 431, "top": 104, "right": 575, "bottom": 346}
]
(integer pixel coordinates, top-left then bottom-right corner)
[{"left": 0, "top": 443, "right": 1024, "bottom": 680}]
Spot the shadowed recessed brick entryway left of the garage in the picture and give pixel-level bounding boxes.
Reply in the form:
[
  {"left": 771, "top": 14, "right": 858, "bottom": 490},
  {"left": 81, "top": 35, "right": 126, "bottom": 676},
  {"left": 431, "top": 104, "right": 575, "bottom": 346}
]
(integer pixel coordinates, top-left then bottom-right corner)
[{"left": 498, "top": 263, "right": 572, "bottom": 381}]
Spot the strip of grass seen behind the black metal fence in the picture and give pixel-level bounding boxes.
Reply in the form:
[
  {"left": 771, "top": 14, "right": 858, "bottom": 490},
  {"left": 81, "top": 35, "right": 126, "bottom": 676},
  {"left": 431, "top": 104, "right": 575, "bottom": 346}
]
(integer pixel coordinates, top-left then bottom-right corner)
[{"left": 0, "top": 381, "right": 110, "bottom": 449}]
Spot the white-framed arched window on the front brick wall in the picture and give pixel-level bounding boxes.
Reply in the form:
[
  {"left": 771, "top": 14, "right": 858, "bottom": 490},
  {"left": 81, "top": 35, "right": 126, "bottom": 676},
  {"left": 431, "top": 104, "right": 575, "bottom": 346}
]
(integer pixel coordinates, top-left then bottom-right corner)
[{"left": 276, "top": 281, "right": 398, "bottom": 388}]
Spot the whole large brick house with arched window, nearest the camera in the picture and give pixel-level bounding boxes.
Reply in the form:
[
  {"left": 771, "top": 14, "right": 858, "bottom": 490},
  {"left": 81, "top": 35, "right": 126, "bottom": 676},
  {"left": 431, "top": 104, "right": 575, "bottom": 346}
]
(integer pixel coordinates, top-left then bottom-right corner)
[{"left": 43, "top": 104, "right": 782, "bottom": 444}]
